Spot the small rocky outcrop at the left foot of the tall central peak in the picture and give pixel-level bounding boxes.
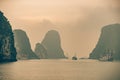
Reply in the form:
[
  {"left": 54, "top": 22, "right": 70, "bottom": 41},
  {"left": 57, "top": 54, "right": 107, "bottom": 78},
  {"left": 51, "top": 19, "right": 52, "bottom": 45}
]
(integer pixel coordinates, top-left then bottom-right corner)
[{"left": 35, "top": 43, "right": 47, "bottom": 59}]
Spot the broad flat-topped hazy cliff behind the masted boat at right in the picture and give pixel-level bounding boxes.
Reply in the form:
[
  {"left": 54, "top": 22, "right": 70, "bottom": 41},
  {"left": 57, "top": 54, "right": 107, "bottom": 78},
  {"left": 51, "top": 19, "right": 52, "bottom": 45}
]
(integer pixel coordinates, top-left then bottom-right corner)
[{"left": 90, "top": 24, "right": 120, "bottom": 60}]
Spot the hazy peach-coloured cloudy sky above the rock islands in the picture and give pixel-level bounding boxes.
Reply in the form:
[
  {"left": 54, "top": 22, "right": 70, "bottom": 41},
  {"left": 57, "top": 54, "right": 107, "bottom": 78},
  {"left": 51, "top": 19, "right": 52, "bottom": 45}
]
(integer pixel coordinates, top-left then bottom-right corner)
[{"left": 0, "top": 0, "right": 120, "bottom": 57}]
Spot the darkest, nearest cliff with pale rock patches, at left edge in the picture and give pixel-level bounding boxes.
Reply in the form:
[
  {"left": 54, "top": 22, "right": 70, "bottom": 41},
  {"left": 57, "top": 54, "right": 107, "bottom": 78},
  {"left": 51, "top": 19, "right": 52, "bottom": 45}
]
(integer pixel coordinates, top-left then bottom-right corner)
[{"left": 0, "top": 11, "right": 17, "bottom": 62}]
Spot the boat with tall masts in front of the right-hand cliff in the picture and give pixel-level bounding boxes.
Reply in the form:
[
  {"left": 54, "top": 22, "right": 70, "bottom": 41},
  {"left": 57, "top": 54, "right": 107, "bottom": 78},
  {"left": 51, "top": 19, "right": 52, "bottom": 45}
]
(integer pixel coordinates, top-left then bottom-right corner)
[{"left": 99, "top": 50, "right": 114, "bottom": 61}]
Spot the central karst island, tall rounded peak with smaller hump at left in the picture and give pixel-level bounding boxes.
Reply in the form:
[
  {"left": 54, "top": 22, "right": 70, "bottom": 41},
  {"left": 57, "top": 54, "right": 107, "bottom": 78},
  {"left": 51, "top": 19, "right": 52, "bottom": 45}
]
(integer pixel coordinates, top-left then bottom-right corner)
[{"left": 35, "top": 30, "right": 65, "bottom": 59}]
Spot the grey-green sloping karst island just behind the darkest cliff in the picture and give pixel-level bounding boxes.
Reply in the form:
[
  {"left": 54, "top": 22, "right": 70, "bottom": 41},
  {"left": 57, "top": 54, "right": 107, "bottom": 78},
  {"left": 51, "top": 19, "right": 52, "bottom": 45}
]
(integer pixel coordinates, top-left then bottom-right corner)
[{"left": 14, "top": 29, "right": 38, "bottom": 59}]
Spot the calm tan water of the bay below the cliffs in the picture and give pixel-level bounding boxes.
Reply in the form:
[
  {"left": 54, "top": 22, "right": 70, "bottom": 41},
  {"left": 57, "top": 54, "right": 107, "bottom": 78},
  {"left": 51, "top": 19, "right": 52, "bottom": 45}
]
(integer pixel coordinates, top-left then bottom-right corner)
[{"left": 0, "top": 60, "right": 119, "bottom": 80}]
